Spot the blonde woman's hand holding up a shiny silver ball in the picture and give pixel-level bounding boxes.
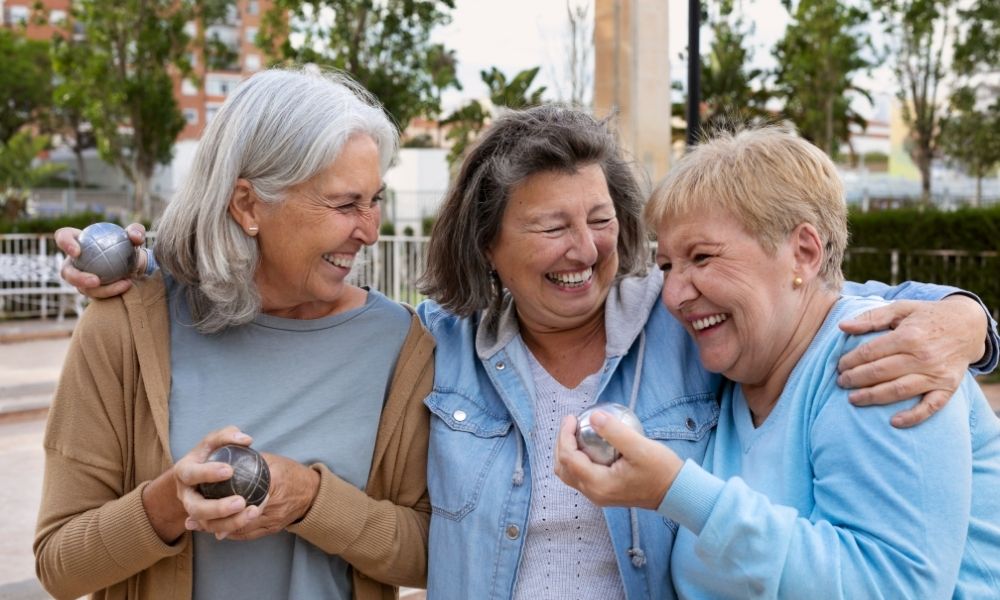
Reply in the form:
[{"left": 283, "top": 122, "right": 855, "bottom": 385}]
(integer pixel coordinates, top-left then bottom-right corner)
[{"left": 555, "top": 411, "right": 684, "bottom": 510}]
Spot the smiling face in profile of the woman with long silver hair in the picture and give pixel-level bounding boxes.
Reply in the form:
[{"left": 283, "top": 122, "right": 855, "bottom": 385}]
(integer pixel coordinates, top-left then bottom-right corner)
[{"left": 253, "top": 134, "right": 382, "bottom": 318}]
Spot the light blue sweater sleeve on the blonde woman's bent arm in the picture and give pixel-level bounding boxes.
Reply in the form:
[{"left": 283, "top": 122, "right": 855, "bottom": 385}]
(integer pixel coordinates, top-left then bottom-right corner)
[{"left": 659, "top": 340, "right": 972, "bottom": 598}]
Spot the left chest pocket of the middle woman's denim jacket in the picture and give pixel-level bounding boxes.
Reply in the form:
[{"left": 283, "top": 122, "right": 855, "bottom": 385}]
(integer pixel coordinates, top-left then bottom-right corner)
[{"left": 424, "top": 390, "right": 512, "bottom": 521}]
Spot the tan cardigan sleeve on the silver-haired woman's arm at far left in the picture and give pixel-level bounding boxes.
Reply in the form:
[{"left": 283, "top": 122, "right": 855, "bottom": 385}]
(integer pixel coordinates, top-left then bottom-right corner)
[{"left": 34, "top": 298, "right": 187, "bottom": 598}]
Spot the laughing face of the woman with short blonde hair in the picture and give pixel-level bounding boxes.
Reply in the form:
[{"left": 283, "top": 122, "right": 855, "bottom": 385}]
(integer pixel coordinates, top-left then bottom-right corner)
[{"left": 656, "top": 209, "right": 802, "bottom": 384}]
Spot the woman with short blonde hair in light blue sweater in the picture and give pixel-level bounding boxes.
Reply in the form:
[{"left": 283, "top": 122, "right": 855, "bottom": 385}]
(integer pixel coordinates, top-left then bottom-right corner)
[{"left": 557, "top": 128, "right": 1000, "bottom": 598}]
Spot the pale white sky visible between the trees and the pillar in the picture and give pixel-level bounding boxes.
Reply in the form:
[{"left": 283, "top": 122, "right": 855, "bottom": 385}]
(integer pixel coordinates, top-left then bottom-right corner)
[{"left": 434, "top": 0, "right": 888, "bottom": 122}]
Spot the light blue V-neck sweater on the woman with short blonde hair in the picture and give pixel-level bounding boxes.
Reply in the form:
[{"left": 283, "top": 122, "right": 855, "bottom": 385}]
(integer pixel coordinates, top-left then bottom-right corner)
[{"left": 658, "top": 297, "right": 1000, "bottom": 598}]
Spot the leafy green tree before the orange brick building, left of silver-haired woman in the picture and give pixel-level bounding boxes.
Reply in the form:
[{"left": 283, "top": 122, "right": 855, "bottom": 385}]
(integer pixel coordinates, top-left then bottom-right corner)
[{"left": 54, "top": 0, "right": 197, "bottom": 217}]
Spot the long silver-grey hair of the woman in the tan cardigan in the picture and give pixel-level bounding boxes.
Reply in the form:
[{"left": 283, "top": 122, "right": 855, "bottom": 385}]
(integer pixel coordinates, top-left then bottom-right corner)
[{"left": 156, "top": 69, "right": 398, "bottom": 333}]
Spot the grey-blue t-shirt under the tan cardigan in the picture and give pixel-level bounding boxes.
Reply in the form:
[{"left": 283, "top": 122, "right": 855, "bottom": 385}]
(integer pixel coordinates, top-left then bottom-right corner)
[{"left": 166, "top": 277, "right": 410, "bottom": 600}]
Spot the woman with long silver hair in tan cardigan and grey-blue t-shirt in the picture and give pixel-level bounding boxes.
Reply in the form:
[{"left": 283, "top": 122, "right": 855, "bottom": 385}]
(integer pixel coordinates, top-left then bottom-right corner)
[{"left": 35, "top": 70, "right": 433, "bottom": 599}]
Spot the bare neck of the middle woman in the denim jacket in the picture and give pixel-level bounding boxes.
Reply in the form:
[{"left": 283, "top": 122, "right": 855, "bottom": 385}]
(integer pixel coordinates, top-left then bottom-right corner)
[{"left": 518, "top": 310, "right": 607, "bottom": 389}]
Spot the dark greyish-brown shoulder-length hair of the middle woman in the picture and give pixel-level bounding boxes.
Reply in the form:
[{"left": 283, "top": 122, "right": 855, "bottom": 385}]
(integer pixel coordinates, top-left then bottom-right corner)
[{"left": 420, "top": 105, "right": 650, "bottom": 316}]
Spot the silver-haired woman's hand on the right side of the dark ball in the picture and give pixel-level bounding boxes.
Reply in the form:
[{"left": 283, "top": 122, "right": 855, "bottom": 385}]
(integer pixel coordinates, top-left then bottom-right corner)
[{"left": 229, "top": 452, "right": 320, "bottom": 540}]
